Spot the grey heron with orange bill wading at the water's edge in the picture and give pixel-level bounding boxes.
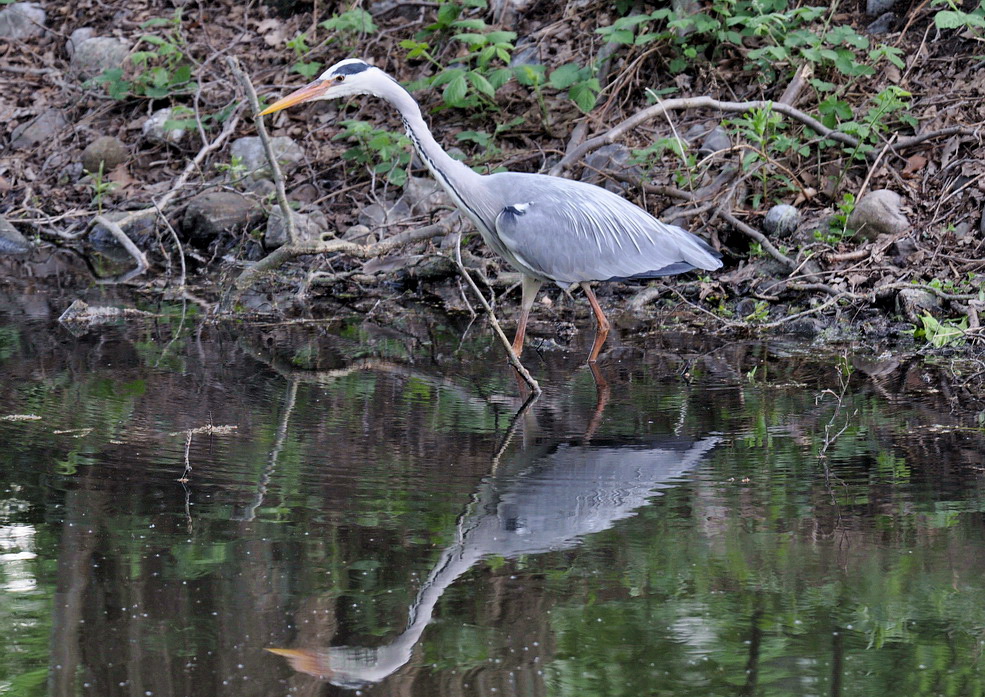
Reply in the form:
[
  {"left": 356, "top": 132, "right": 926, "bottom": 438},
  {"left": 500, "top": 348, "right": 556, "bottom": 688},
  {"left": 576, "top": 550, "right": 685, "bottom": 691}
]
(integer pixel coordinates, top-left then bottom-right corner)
[{"left": 260, "top": 58, "right": 722, "bottom": 363}]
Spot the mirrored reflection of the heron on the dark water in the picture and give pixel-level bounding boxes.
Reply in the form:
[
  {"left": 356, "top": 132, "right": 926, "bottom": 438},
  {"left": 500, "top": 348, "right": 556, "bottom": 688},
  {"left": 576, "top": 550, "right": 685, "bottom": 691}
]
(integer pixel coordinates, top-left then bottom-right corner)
[{"left": 268, "top": 437, "right": 718, "bottom": 688}]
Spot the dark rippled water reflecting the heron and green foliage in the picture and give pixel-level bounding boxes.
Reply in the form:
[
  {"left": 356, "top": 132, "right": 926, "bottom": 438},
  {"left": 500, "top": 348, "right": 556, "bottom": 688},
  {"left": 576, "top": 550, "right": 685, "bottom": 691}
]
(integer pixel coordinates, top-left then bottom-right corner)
[{"left": 0, "top": 290, "right": 985, "bottom": 697}]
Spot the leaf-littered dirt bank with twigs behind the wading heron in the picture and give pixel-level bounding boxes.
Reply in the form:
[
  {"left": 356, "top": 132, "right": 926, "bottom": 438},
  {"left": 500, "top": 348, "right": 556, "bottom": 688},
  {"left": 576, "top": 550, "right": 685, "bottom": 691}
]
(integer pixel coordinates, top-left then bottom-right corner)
[{"left": 0, "top": 0, "right": 985, "bottom": 348}]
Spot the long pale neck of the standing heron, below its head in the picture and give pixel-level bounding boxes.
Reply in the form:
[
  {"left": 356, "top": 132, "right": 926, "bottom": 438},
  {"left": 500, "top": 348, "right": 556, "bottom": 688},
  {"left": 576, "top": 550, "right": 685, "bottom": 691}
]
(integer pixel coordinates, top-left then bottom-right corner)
[{"left": 390, "top": 89, "right": 498, "bottom": 219}]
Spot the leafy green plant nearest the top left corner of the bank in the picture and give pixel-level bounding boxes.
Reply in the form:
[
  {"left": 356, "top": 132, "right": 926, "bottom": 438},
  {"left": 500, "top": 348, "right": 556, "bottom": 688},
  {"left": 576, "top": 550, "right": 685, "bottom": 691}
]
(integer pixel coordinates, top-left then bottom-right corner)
[{"left": 93, "top": 8, "right": 198, "bottom": 99}]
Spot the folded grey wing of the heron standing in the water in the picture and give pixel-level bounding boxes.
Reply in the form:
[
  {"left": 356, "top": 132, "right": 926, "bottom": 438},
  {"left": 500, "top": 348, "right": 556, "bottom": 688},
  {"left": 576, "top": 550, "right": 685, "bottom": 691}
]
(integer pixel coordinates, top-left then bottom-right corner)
[{"left": 496, "top": 177, "right": 722, "bottom": 283}]
